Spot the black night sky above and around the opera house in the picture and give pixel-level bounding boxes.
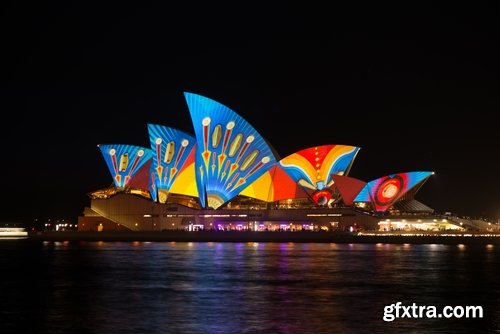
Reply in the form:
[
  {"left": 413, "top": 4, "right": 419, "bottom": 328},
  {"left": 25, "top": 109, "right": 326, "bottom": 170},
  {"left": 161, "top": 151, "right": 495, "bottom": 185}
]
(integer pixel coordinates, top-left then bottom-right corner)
[{"left": 0, "top": 1, "right": 500, "bottom": 220}]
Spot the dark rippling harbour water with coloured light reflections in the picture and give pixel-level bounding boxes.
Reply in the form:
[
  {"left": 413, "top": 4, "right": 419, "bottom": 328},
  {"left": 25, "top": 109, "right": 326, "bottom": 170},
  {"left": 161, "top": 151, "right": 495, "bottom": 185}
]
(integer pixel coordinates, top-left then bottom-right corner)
[{"left": 0, "top": 240, "right": 500, "bottom": 333}]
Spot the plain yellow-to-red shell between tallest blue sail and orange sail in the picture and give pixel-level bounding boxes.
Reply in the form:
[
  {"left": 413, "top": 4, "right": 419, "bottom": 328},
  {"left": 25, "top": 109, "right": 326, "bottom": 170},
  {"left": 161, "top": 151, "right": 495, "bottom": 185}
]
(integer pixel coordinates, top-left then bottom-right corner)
[{"left": 240, "top": 163, "right": 308, "bottom": 202}]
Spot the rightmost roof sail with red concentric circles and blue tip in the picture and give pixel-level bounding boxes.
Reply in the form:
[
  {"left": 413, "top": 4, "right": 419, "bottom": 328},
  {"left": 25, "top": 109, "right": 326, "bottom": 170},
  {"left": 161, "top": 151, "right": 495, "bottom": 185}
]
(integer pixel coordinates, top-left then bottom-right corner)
[{"left": 354, "top": 171, "right": 432, "bottom": 211}]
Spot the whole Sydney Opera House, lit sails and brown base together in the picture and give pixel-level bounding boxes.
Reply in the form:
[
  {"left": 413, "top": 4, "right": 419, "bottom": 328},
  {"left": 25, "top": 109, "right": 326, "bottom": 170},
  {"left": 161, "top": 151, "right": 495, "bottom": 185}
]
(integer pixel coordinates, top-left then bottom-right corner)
[{"left": 78, "top": 93, "right": 488, "bottom": 231}]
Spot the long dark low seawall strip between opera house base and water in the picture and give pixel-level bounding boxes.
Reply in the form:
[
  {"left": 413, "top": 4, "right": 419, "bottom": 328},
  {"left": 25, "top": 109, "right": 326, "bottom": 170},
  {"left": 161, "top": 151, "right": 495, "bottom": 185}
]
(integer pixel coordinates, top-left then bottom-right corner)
[{"left": 27, "top": 231, "right": 500, "bottom": 245}]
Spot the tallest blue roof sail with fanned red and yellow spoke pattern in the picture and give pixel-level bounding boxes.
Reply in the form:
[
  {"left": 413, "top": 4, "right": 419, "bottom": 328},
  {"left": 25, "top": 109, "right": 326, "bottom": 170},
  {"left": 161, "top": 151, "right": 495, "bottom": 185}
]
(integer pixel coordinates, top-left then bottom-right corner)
[{"left": 184, "top": 93, "right": 276, "bottom": 209}]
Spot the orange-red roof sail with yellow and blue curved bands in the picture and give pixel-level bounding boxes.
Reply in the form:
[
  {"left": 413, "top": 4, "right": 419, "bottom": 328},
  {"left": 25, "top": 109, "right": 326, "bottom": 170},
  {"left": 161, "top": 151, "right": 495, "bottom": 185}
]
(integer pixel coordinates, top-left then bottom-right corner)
[{"left": 279, "top": 145, "right": 359, "bottom": 205}]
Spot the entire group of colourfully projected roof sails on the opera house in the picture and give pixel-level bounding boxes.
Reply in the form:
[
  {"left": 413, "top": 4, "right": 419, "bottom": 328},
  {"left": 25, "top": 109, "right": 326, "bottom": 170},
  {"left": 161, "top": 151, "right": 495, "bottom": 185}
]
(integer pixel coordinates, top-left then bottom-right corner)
[{"left": 94, "top": 92, "right": 433, "bottom": 212}]
